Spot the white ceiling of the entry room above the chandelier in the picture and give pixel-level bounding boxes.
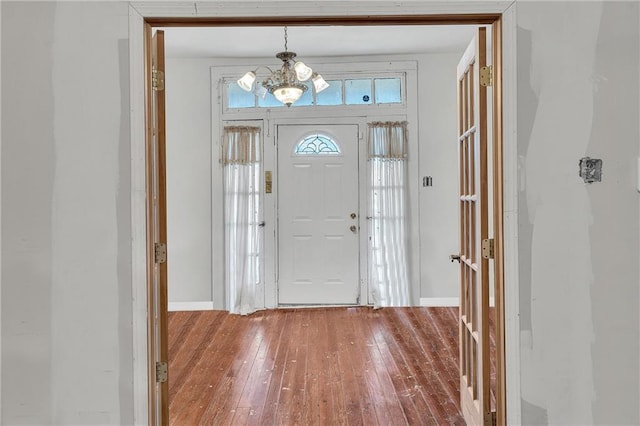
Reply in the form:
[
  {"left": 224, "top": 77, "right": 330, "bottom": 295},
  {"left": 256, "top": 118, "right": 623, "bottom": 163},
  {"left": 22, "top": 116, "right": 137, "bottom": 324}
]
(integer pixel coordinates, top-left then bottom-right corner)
[{"left": 164, "top": 25, "right": 476, "bottom": 58}]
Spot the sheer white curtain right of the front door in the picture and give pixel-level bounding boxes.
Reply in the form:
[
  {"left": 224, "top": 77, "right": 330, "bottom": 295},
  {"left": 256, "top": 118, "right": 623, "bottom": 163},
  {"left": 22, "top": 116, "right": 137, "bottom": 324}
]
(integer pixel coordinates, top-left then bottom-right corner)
[{"left": 368, "top": 122, "right": 410, "bottom": 308}]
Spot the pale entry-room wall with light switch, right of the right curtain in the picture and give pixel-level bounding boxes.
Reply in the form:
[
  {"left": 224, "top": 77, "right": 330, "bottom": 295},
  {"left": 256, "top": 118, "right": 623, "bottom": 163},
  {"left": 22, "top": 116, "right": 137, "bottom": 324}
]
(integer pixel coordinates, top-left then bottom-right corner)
[{"left": 418, "top": 52, "right": 462, "bottom": 298}]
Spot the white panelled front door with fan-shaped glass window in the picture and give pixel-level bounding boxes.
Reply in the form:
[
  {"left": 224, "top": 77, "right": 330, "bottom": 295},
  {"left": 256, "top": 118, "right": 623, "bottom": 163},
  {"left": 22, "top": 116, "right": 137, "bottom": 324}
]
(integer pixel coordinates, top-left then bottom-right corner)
[{"left": 277, "top": 124, "right": 360, "bottom": 305}]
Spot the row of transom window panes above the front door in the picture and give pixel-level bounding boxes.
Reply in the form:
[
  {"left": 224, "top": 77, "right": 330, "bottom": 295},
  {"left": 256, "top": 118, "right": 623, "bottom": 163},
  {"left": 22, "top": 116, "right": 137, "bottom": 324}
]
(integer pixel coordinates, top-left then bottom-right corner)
[{"left": 224, "top": 76, "right": 404, "bottom": 109}]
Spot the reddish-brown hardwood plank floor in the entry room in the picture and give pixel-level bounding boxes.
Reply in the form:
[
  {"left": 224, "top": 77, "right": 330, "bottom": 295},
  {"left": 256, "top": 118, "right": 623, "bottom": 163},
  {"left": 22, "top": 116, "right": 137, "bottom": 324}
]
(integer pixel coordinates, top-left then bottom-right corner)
[{"left": 169, "top": 307, "right": 464, "bottom": 426}]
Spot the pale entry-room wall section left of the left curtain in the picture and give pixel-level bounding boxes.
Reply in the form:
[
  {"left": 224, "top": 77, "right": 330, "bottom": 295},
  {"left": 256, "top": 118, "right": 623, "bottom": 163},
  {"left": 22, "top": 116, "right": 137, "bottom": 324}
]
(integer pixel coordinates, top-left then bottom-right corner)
[{"left": 165, "top": 58, "right": 212, "bottom": 302}]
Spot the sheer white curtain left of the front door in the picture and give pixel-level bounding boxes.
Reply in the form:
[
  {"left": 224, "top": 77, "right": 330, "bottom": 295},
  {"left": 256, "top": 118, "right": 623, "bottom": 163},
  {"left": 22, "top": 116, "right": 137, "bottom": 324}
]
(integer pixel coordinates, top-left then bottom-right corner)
[{"left": 223, "top": 127, "right": 262, "bottom": 315}]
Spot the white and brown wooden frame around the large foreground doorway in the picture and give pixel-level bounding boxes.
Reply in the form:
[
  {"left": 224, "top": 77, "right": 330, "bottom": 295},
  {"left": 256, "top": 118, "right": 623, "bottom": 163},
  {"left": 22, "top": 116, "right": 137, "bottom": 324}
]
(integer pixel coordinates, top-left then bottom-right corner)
[{"left": 129, "top": 1, "right": 521, "bottom": 425}]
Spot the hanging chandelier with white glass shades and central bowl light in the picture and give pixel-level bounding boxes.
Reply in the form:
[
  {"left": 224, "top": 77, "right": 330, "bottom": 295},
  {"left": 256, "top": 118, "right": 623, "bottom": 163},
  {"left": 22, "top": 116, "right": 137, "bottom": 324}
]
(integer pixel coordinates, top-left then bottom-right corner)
[{"left": 238, "top": 27, "right": 329, "bottom": 107}]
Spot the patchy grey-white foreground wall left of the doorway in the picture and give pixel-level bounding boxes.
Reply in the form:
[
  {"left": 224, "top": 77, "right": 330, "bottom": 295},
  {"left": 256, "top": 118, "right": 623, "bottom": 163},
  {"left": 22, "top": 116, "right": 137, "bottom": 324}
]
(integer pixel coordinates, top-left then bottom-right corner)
[{"left": 1, "top": 2, "right": 133, "bottom": 425}]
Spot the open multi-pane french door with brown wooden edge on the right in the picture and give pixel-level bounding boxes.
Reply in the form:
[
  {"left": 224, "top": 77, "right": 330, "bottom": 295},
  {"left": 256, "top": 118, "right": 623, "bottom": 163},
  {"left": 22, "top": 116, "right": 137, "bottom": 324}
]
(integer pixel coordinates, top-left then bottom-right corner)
[{"left": 457, "top": 27, "right": 495, "bottom": 425}]
